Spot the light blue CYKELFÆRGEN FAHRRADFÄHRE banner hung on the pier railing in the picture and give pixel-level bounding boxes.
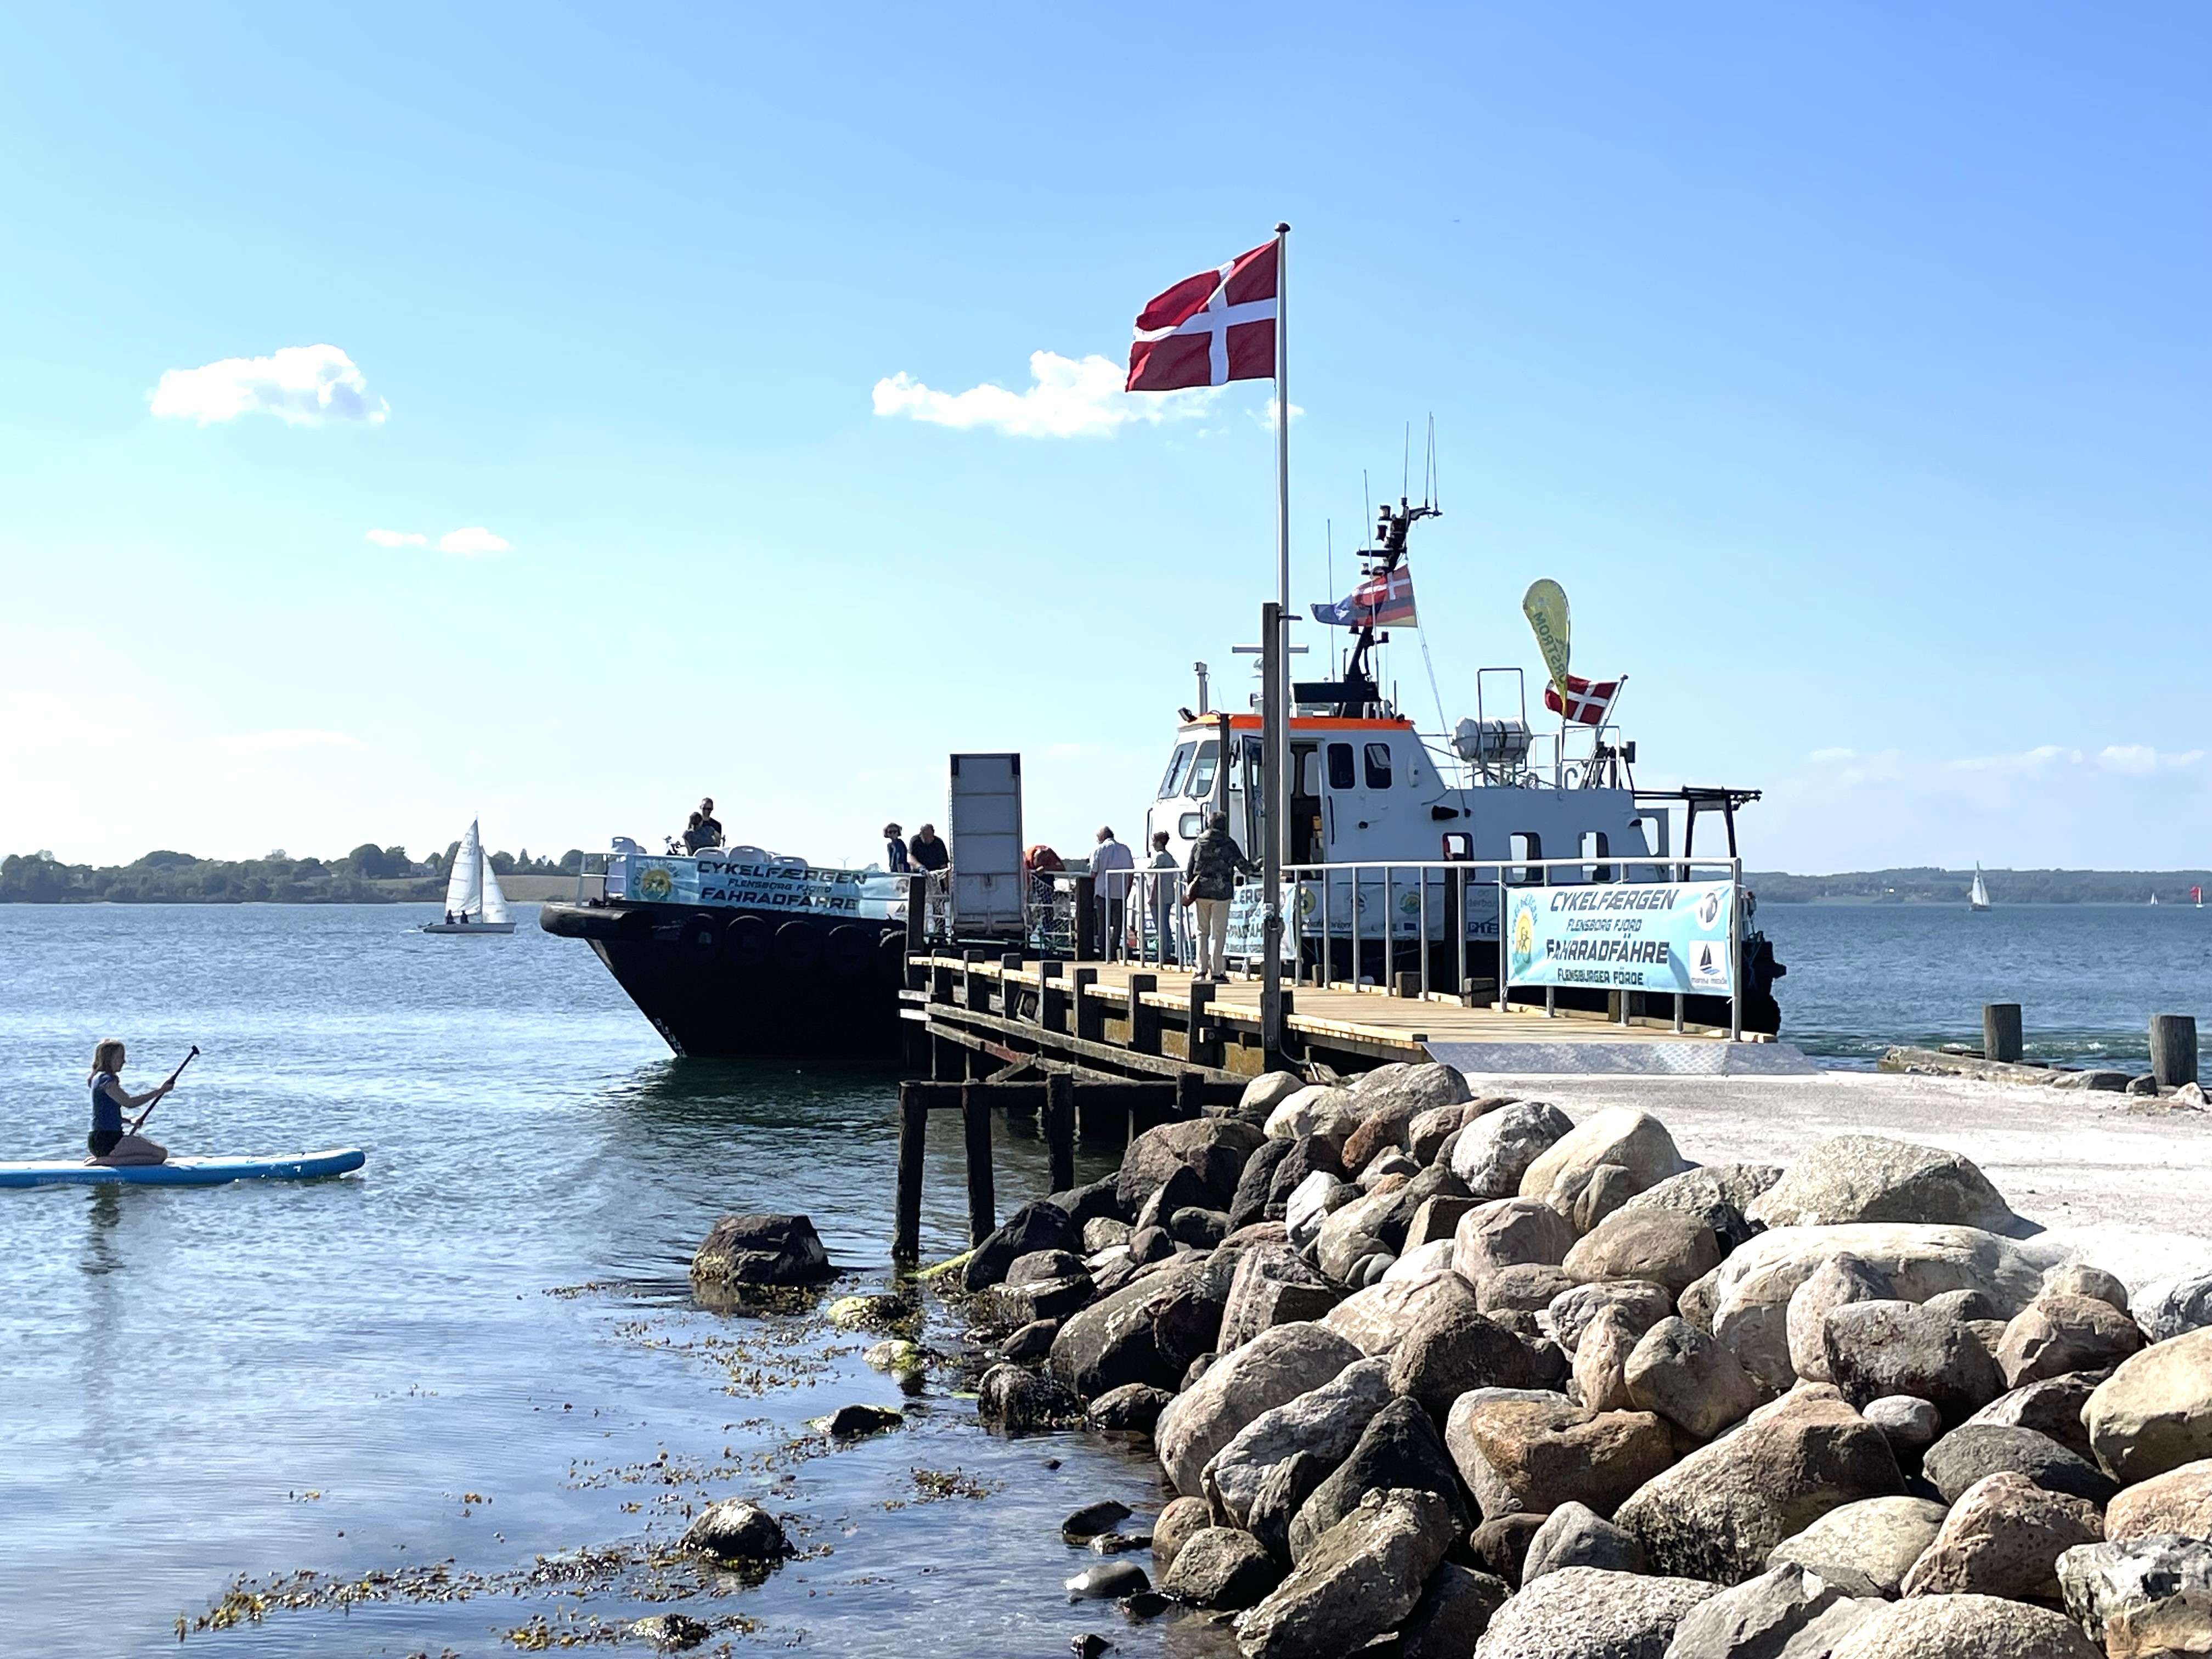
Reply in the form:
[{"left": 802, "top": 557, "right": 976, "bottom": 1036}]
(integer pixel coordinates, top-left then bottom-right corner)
[{"left": 1506, "top": 881, "right": 1736, "bottom": 995}]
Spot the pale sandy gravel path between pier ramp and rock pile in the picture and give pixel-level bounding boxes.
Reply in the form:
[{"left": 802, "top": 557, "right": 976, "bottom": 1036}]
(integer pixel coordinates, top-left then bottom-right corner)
[{"left": 1469, "top": 1070, "right": 2212, "bottom": 1290}]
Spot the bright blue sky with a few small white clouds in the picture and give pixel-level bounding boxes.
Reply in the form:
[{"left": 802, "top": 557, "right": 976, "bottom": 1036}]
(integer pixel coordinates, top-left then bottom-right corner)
[{"left": 0, "top": 4, "right": 2212, "bottom": 870}]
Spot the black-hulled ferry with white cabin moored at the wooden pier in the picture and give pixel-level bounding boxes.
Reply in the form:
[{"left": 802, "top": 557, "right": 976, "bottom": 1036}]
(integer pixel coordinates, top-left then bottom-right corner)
[{"left": 540, "top": 502, "right": 1785, "bottom": 1062}]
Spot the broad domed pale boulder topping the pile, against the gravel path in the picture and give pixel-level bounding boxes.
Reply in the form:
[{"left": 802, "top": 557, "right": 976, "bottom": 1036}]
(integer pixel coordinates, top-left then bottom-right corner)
[{"left": 1743, "top": 1135, "right": 2035, "bottom": 1237}]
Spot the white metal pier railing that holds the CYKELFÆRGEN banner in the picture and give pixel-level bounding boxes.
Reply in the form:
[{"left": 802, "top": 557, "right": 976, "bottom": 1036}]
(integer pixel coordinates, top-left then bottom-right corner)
[{"left": 1283, "top": 854, "right": 1747, "bottom": 1037}]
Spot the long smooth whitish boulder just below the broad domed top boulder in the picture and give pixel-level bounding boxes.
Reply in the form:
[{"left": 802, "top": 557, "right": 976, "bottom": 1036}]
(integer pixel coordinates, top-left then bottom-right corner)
[{"left": 1679, "top": 1221, "right": 2042, "bottom": 1391}]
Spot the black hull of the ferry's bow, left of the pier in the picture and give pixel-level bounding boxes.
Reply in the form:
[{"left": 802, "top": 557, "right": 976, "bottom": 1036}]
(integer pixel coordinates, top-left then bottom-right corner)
[{"left": 538, "top": 900, "right": 907, "bottom": 1062}]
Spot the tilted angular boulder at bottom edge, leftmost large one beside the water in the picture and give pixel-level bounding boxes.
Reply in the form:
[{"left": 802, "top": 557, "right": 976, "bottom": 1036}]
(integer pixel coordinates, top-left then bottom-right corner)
[{"left": 1237, "top": 1491, "right": 1453, "bottom": 1659}]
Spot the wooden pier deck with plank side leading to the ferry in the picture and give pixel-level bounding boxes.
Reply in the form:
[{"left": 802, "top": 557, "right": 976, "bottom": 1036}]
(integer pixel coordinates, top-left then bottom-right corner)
[{"left": 902, "top": 951, "right": 1812, "bottom": 1088}]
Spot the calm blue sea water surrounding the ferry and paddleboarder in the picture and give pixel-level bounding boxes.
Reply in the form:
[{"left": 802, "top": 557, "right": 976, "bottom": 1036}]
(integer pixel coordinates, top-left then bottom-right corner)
[{"left": 0, "top": 905, "right": 2212, "bottom": 1657}]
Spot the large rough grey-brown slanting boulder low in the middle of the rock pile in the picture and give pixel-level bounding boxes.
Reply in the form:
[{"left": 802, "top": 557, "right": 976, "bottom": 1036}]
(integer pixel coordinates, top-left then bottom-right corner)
[{"left": 1615, "top": 1396, "right": 1905, "bottom": 1584}]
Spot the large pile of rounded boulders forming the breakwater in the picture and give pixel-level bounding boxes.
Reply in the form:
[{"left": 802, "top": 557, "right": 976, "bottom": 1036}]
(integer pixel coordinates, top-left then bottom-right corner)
[{"left": 967, "top": 1064, "right": 2212, "bottom": 1659}]
